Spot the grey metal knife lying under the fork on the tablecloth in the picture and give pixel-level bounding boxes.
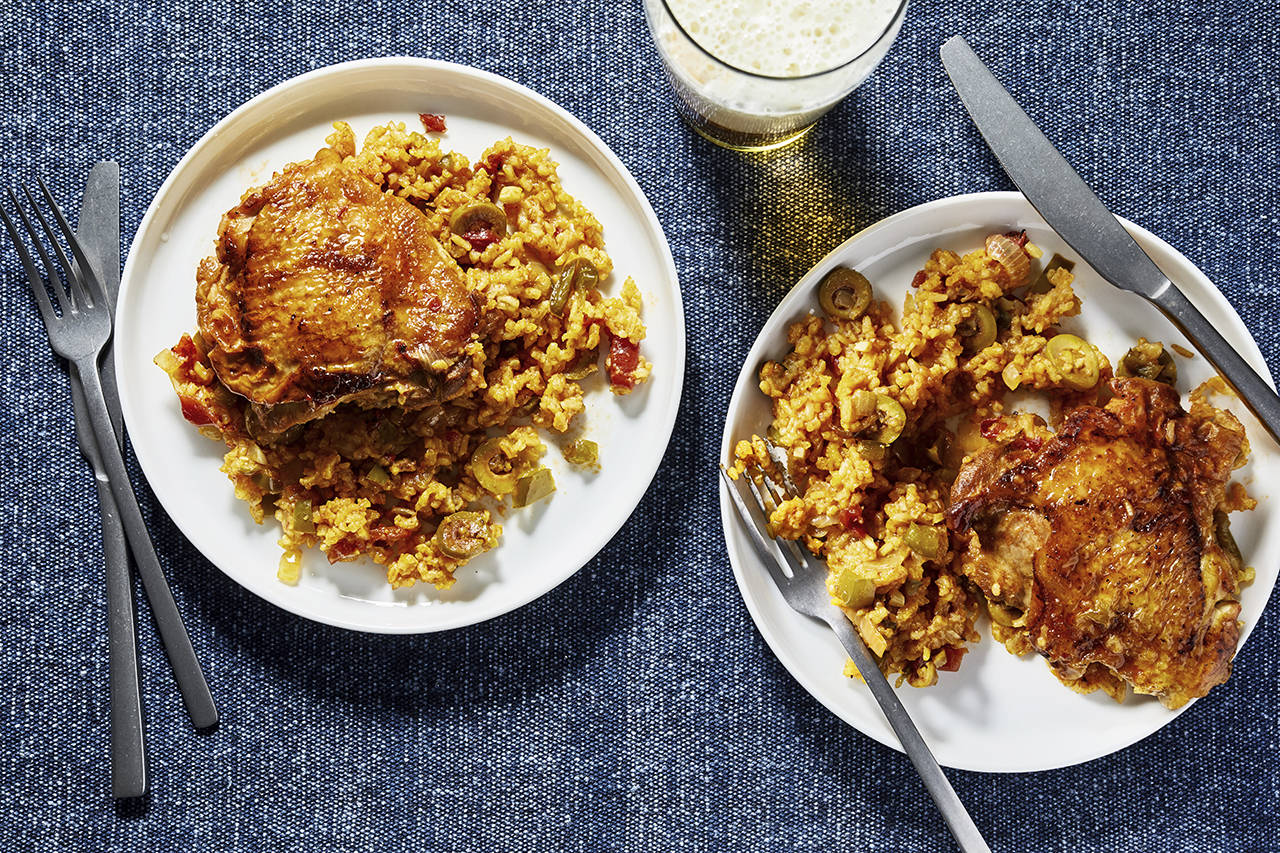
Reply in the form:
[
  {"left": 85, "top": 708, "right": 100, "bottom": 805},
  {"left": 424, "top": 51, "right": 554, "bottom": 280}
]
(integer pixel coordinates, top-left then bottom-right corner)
[{"left": 70, "top": 160, "right": 147, "bottom": 799}]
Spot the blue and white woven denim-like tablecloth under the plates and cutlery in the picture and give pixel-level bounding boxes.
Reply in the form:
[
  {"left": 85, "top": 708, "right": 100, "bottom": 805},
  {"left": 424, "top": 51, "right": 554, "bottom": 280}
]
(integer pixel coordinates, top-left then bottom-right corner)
[{"left": 0, "top": 0, "right": 1280, "bottom": 853}]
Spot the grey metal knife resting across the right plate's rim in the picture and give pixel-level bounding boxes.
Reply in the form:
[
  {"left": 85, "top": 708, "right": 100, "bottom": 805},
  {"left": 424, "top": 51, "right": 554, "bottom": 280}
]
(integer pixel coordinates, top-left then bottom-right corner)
[{"left": 941, "top": 36, "right": 1280, "bottom": 443}]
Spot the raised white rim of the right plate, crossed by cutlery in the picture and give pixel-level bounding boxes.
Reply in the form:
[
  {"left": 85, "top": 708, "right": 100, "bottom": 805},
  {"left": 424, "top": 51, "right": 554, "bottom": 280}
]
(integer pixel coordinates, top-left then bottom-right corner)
[{"left": 716, "top": 190, "right": 1280, "bottom": 774}]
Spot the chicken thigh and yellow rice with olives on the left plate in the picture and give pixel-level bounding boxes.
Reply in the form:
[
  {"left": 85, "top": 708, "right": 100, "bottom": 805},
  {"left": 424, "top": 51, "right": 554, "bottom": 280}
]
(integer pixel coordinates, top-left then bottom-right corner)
[{"left": 156, "top": 114, "right": 650, "bottom": 587}]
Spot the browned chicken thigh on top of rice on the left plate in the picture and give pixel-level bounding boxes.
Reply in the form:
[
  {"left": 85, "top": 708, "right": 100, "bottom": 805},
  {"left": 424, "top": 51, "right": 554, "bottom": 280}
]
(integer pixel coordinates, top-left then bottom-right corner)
[{"left": 196, "top": 149, "right": 476, "bottom": 432}]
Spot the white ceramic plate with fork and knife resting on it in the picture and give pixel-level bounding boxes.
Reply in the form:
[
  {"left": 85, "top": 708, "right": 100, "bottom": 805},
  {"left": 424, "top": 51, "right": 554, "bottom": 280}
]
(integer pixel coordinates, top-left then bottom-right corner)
[{"left": 721, "top": 192, "right": 1280, "bottom": 771}]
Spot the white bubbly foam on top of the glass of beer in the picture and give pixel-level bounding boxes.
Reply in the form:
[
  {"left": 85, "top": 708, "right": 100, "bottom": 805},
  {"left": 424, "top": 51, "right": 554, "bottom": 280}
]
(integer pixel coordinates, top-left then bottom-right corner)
[{"left": 667, "top": 0, "right": 900, "bottom": 77}]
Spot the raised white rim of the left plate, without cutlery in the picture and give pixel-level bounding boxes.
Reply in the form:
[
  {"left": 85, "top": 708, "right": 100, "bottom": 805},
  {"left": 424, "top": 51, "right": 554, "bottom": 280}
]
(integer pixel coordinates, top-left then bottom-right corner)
[{"left": 111, "top": 55, "right": 687, "bottom": 634}]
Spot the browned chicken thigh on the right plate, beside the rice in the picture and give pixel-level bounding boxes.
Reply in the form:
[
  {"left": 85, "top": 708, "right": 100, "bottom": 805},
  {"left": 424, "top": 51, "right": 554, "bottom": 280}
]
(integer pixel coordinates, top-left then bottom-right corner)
[{"left": 948, "top": 379, "right": 1248, "bottom": 708}]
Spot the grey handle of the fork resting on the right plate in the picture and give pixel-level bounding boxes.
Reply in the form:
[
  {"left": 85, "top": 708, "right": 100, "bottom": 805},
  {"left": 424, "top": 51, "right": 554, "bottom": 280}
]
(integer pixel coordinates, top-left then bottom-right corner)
[{"left": 823, "top": 610, "right": 991, "bottom": 853}]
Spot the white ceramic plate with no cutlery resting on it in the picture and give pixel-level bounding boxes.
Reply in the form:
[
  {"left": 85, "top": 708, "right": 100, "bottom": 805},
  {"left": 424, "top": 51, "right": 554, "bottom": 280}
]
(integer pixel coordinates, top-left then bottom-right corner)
[{"left": 115, "top": 58, "right": 685, "bottom": 633}]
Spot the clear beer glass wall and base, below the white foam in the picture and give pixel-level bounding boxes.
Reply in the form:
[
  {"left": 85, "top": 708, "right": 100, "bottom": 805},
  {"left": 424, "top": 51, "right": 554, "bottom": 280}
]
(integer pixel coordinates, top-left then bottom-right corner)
[{"left": 645, "top": 0, "right": 908, "bottom": 151}]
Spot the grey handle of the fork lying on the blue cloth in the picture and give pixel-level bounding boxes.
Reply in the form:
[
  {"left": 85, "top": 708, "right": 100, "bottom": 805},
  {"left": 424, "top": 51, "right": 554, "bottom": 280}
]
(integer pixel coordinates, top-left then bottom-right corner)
[{"left": 76, "top": 356, "right": 218, "bottom": 729}]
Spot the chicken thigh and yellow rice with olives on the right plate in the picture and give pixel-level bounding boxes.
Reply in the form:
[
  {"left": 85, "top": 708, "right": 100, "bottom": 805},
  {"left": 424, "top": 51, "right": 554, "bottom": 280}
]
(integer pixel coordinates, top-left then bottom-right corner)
[{"left": 730, "top": 233, "right": 1253, "bottom": 707}]
